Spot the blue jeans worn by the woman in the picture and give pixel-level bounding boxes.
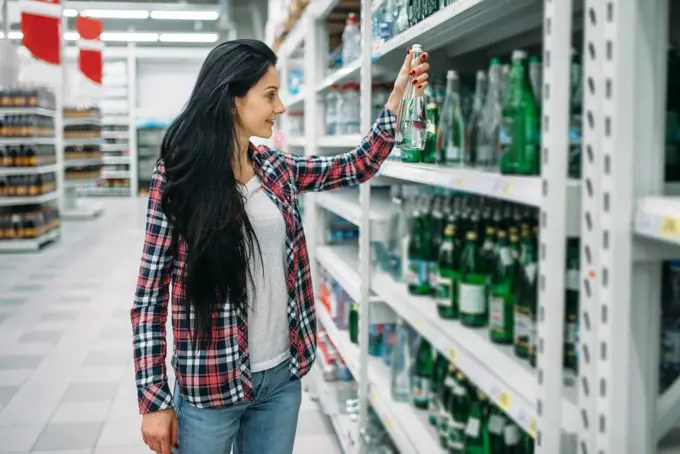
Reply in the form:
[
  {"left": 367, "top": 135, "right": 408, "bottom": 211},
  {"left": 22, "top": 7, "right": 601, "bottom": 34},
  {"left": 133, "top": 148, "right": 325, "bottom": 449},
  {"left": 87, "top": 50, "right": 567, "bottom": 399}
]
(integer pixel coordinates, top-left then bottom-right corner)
[{"left": 174, "top": 361, "right": 302, "bottom": 454}]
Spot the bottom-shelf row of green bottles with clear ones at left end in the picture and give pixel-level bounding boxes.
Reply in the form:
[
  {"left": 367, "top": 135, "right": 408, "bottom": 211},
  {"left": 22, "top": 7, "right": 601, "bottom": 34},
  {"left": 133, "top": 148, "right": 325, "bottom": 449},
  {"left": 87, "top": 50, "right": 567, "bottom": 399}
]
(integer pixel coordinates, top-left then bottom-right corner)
[{"left": 404, "top": 330, "right": 534, "bottom": 454}]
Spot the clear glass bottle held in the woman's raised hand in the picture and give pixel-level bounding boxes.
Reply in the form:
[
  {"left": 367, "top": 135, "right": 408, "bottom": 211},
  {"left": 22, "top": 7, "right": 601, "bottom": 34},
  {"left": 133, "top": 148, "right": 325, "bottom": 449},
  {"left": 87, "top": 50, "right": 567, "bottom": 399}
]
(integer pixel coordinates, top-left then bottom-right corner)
[{"left": 395, "top": 44, "right": 427, "bottom": 154}]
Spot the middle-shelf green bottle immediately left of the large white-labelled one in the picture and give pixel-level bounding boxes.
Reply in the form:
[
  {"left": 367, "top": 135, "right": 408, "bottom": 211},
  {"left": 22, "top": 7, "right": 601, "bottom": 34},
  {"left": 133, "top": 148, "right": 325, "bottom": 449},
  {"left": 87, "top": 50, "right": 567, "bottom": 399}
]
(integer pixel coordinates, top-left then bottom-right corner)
[{"left": 436, "top": 222, "right": 460, "bottom": 320}]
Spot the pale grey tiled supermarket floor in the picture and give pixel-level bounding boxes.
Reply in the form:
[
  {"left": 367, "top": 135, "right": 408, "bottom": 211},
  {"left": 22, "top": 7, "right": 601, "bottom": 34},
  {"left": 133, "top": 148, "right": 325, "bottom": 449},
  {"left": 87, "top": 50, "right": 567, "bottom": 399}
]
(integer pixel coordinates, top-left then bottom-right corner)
[{"left": 0, "top": 199, "right": 340, "bottom": 454}]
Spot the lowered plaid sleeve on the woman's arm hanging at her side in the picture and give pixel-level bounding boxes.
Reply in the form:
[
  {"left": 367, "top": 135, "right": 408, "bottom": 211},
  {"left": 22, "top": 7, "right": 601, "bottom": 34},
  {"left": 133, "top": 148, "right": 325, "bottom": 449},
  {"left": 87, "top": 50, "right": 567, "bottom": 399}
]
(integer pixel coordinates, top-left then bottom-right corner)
[{"left": 131, "top": 161, "right": 173, "bottom": 414}]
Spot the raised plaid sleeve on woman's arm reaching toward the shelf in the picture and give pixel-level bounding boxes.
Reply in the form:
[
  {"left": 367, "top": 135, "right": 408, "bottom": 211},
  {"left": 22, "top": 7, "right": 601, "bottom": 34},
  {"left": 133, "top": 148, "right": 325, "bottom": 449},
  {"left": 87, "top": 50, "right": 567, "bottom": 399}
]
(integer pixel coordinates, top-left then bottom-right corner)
[{"left": 286, "top": 107, "right": 397, "bottom": 193}]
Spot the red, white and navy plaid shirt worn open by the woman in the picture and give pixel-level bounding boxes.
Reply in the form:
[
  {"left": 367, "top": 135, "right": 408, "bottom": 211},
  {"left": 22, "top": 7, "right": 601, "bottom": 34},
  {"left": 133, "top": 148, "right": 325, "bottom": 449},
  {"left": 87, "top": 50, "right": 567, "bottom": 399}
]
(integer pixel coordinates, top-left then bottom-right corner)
[{"left": 131, "top": 108, "right": 397, "bottom": 414}]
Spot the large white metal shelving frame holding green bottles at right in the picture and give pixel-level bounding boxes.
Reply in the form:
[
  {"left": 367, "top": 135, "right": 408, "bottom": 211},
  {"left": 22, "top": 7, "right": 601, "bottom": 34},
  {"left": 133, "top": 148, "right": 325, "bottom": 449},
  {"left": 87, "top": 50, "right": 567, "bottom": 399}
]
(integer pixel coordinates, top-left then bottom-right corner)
[{"left": 278, "top": 0, "right": 680, "bottom": 454}]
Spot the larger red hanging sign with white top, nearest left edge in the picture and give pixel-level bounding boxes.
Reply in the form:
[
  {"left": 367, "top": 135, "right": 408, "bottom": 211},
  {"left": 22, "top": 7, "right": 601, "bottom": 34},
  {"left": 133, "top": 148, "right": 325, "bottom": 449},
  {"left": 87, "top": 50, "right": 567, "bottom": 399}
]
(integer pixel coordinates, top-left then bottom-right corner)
[{"left": 19, "top": 0, "right": 62, "bottom": 65}]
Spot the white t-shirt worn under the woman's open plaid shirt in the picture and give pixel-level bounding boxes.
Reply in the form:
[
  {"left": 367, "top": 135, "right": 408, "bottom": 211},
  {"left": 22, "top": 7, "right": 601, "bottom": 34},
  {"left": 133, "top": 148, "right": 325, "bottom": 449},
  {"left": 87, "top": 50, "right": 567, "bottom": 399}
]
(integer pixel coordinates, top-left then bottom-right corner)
[{"left": 240, "top": 176, "right": 290, "bottom": 373}]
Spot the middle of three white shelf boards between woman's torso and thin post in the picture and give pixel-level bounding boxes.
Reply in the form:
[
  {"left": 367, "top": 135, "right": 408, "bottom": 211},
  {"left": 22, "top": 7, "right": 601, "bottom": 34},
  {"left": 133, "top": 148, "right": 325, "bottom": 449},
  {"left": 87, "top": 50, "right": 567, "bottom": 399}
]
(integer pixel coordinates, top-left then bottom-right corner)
[{"left": 316, "top": 244, "right": 361, "bottom": 301}]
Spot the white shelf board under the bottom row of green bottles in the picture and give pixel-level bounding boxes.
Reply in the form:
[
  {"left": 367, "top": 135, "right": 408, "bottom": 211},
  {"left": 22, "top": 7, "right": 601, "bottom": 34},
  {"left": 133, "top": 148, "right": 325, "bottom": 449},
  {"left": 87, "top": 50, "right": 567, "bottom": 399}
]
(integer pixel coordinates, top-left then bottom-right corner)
[{"left": 316, "top": 303, "right": 444, "bottom": 454}]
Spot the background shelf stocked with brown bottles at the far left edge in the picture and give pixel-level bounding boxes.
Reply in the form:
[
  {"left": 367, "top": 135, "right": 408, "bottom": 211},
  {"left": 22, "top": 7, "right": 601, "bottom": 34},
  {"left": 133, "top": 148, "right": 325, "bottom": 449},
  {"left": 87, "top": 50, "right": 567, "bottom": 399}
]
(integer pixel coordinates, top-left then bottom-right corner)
[{"left": 0, "top": 88, "right": 60, "bottom": 252}]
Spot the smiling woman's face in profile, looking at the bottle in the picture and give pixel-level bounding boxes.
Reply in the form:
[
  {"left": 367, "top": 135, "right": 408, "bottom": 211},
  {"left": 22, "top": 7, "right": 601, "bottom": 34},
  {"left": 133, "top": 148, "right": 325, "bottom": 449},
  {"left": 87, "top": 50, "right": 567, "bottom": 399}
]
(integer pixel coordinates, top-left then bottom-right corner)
[{"left": 236, "top": 66, "right": 286, "bottom": 139}]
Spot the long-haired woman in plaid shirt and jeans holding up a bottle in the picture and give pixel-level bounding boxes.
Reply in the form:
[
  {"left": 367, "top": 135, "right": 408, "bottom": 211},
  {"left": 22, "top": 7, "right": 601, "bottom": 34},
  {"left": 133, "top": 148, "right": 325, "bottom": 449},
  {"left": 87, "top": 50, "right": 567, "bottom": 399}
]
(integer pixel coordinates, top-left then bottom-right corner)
[{"left": 131, "top": 40, "right": 429, "bottom": 454}]
